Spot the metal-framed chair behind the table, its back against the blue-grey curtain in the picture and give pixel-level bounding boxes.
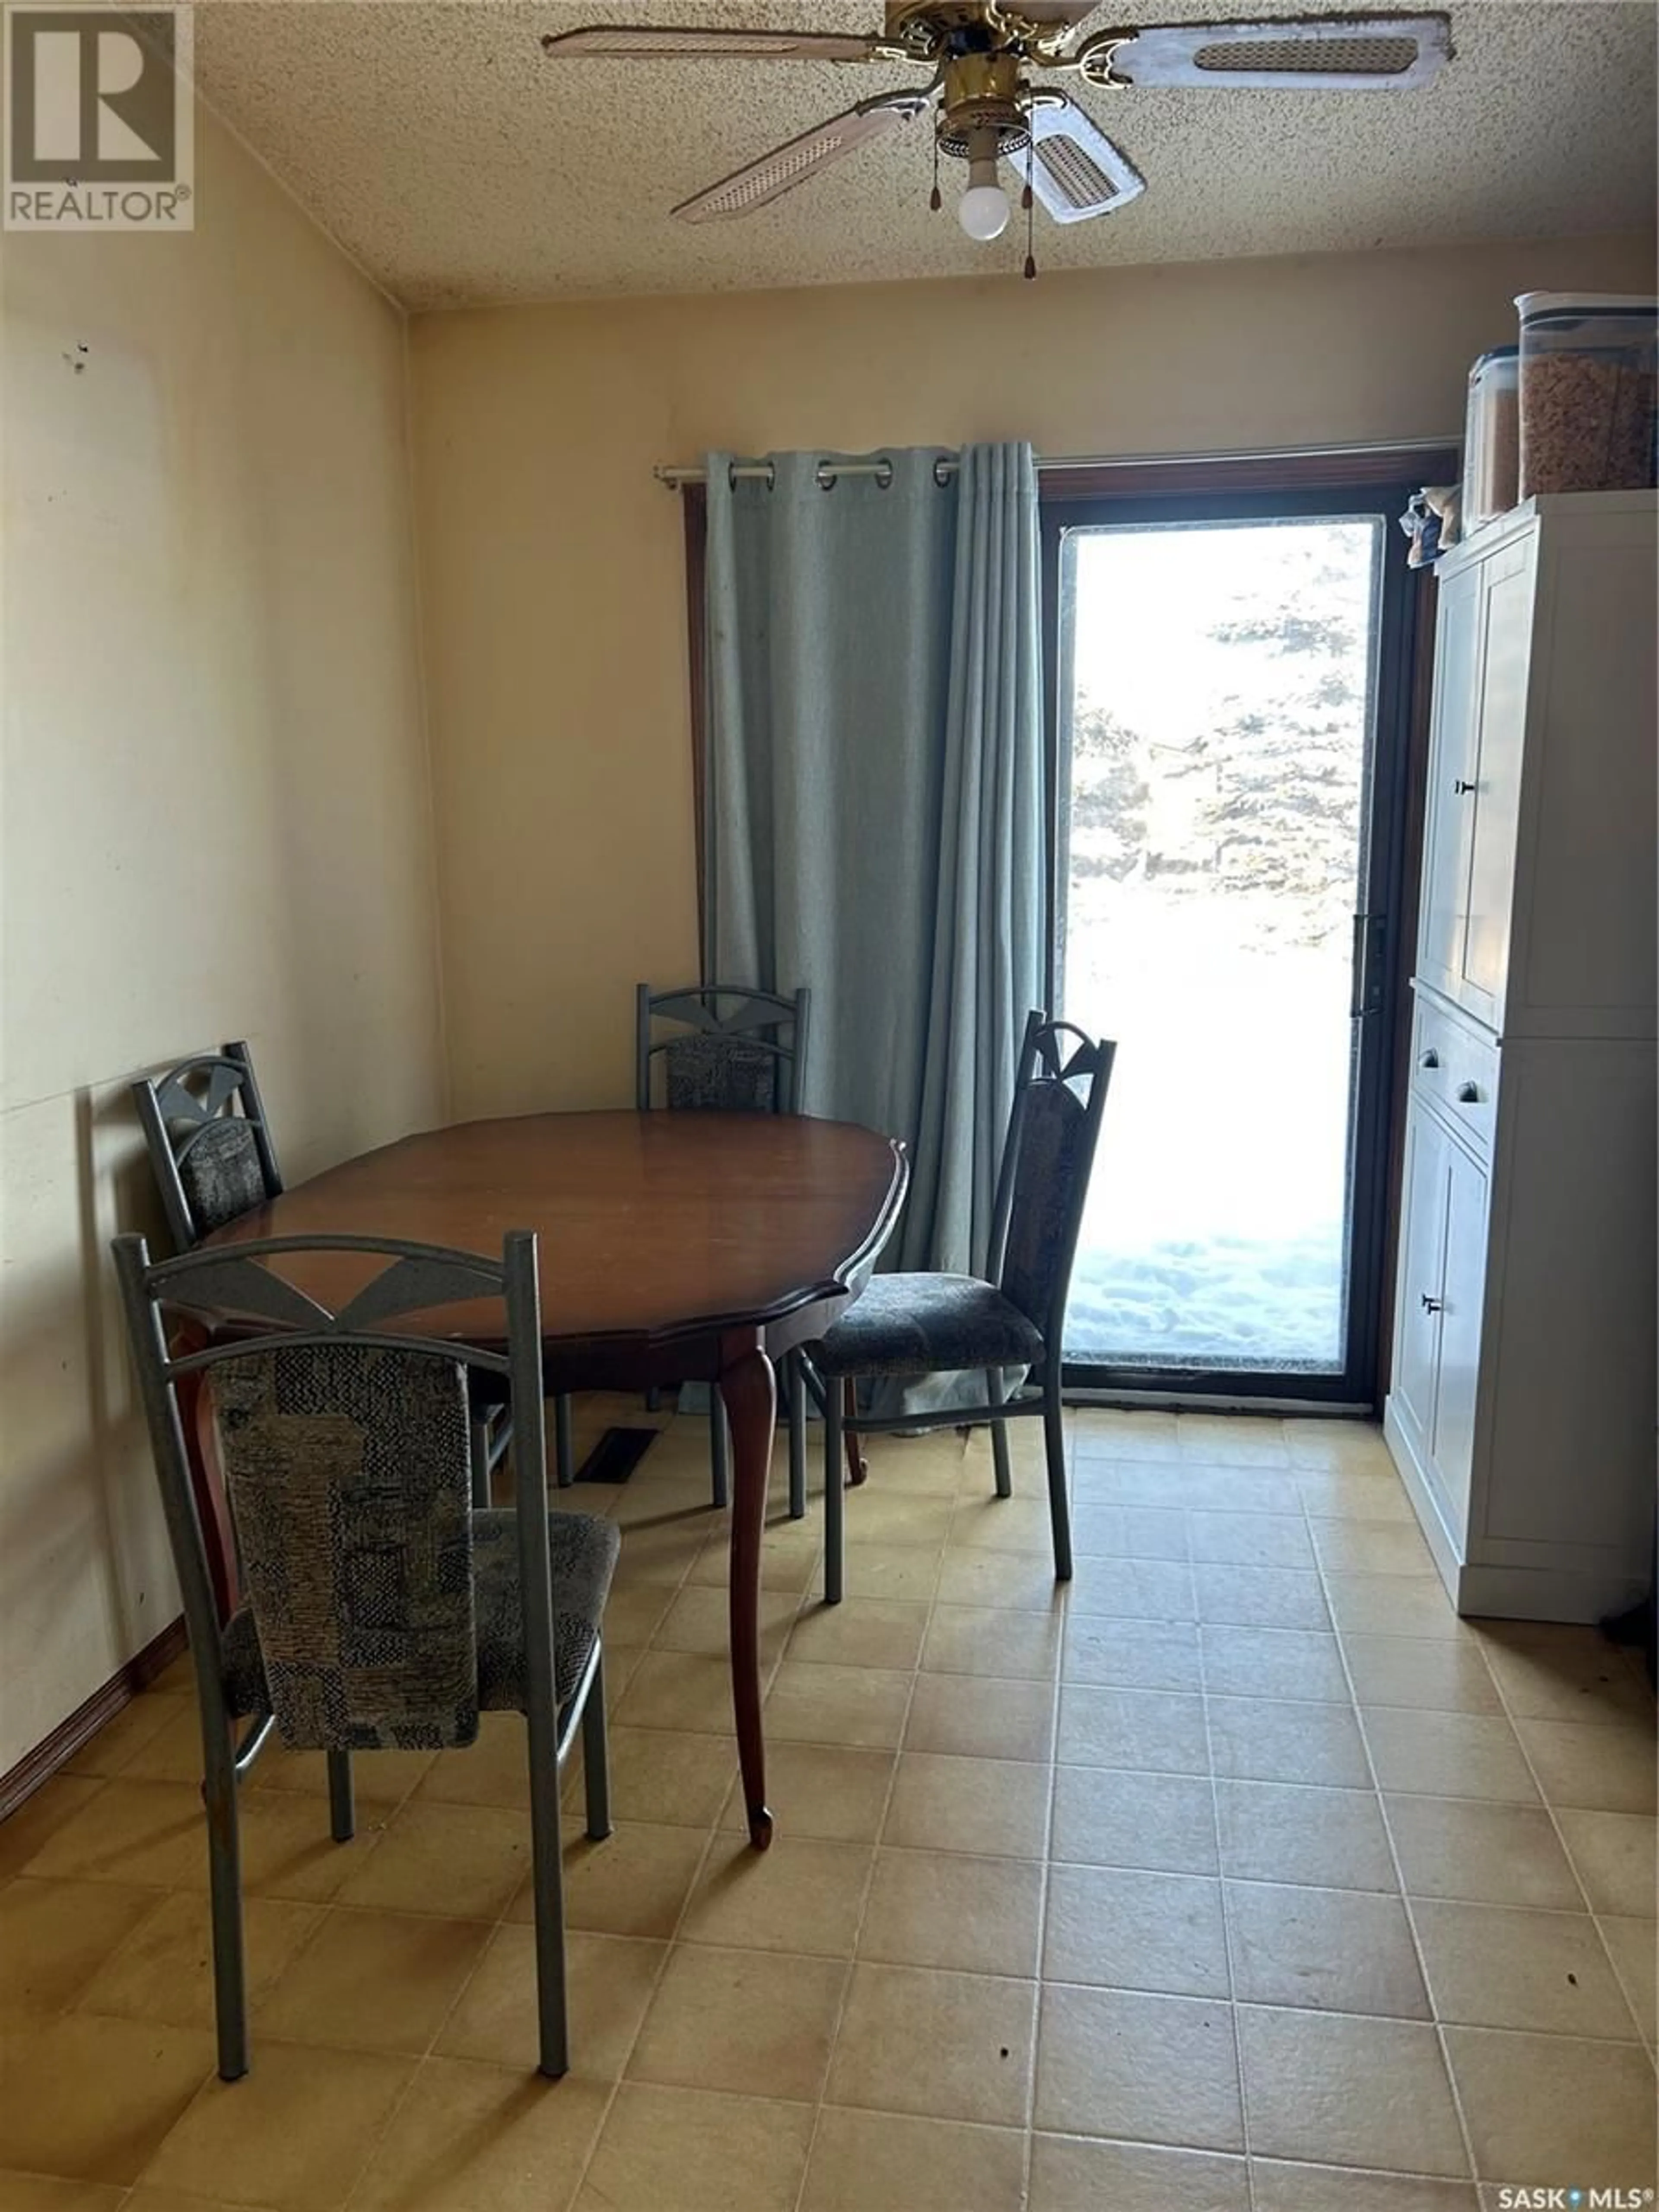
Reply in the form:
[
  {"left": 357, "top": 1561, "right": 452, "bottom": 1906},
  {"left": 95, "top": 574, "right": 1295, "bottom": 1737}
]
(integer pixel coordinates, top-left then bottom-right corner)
[{"left": 635, "top": 982, "right": 812, "bottom": 1519}]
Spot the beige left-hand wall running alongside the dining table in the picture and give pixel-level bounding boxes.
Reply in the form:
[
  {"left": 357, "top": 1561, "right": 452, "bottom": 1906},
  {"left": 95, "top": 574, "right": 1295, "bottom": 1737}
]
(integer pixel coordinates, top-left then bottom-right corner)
[{"left": 0, "top": 126, "right": 445, "bottom": 1772}]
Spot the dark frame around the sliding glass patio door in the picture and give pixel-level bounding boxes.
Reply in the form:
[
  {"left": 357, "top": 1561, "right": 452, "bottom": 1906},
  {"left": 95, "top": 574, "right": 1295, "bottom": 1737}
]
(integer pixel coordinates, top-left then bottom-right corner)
[{"left": 1039, "top": 449, "right": 1460, "bottom": 1411}]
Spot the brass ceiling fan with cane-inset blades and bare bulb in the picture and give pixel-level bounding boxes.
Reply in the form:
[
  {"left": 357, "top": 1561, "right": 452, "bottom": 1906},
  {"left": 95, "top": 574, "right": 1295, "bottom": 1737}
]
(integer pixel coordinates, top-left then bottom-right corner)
[{"left": 542, "top": 0, "right": 1451, "bottom": 276}]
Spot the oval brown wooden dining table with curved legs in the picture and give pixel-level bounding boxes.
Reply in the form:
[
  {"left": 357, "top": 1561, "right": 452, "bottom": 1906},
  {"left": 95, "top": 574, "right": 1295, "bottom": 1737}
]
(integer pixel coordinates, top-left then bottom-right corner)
[{"left": 208, "top": 1110, "right": 909, "bottom": 1849}]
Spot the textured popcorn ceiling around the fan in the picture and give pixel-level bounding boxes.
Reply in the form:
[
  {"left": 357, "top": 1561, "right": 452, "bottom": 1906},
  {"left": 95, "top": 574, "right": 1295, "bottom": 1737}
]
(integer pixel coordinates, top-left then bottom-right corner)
[{"left": 197, "top": 0, "right": 1655, "bottom": 308}]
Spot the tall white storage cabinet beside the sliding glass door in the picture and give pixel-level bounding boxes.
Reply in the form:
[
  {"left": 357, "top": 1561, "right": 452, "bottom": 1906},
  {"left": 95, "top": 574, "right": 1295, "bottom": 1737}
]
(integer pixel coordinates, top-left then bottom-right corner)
[{"left": 1385, "top": 493, "right": 1659, "bottom": 1621}]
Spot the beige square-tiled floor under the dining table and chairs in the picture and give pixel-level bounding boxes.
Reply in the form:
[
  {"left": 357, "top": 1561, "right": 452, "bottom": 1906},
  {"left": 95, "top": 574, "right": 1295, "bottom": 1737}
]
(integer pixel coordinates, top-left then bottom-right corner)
[{"left": 0, "top": 1402, "right": 1655, "bottom": 2212}]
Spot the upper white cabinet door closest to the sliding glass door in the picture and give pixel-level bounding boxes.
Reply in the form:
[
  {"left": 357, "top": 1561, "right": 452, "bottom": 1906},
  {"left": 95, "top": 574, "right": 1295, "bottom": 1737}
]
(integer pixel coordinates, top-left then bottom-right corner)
[{"left": 1418, "top": 562, "right": 1484, "bottom": 998}]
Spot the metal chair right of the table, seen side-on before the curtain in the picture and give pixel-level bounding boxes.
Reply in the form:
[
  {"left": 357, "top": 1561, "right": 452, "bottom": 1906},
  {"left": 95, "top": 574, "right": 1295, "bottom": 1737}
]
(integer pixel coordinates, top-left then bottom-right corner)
[{"left": 805, "top": 1011, "right": 1117, "bottom": 1606}]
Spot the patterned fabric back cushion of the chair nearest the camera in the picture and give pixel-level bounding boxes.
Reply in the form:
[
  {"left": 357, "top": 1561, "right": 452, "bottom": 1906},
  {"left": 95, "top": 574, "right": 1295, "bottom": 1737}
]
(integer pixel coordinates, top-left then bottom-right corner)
[{"left": 213, "top": 1345, "right": 478, "bottom": 1752}]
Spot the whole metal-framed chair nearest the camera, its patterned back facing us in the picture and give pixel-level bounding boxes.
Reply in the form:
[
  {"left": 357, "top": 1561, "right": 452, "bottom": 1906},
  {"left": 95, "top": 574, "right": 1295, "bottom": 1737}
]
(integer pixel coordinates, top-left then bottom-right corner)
[{"left": 115, "top": 1230, "right": 620, "bottom": 2082}]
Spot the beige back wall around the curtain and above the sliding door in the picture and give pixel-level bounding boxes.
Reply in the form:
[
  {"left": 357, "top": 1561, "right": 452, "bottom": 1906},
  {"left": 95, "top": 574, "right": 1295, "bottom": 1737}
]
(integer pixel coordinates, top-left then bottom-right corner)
[{"left": 411, "top": 239, "right": 1653, "bottom": 1115}]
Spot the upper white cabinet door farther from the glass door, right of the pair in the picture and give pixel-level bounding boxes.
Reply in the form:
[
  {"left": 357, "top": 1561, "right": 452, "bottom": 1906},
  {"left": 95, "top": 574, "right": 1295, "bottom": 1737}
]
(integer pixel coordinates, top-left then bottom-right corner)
[{"left": 1453, "top": 537, "right": 1537, "bottom": 1029}]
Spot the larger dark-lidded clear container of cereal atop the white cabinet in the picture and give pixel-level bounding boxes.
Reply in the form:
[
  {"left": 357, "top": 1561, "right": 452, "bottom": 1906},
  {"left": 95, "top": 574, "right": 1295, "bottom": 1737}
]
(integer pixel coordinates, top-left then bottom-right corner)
[{"left": 1515, "top": 292, "right": 1659, "bottom": 500}]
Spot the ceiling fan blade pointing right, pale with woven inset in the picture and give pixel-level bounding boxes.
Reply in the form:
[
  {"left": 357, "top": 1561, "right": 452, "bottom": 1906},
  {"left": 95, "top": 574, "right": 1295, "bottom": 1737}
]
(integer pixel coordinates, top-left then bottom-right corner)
[{"left": 1071, "top": 16, "right": 1451, "bottom": 93}]
